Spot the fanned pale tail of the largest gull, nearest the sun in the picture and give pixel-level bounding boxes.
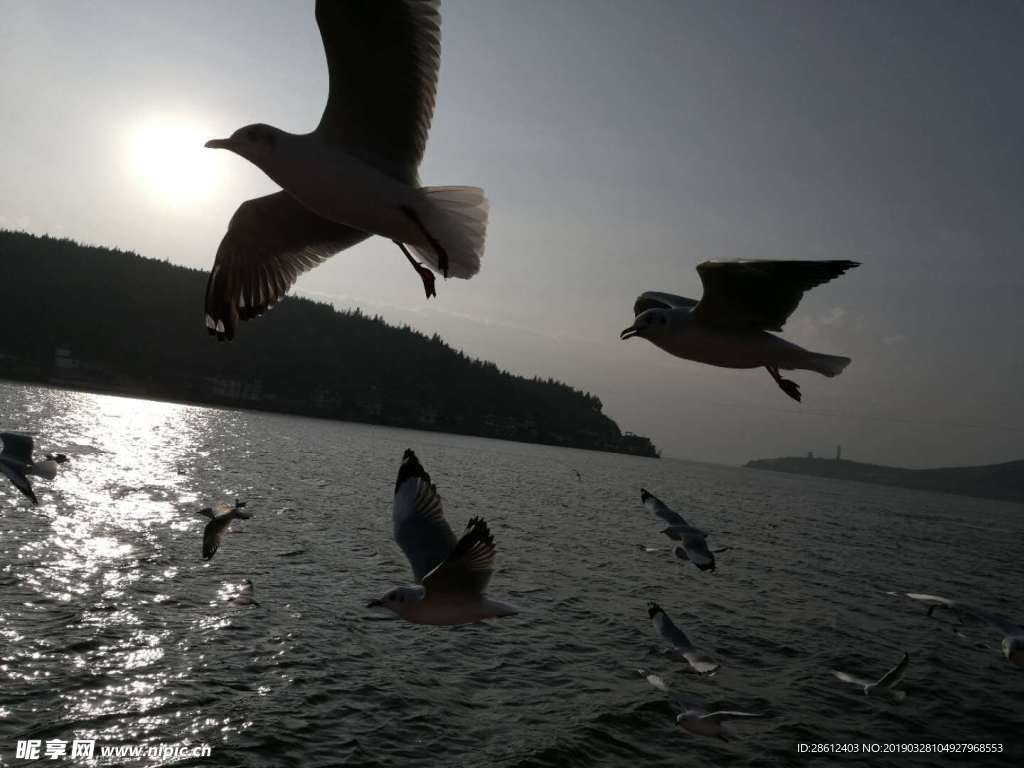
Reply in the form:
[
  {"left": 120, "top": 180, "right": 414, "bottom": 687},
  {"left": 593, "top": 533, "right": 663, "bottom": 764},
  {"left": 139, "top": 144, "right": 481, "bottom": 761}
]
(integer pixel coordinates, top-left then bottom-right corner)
[{"left": 409, "top": 186, "right": 488, "bottom": 279}]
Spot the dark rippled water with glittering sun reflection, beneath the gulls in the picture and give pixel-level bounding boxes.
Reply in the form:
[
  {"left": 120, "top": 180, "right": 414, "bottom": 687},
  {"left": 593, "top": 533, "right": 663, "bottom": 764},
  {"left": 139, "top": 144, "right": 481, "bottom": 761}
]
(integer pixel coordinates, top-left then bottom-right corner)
[{"left": 0, "top": 384, "right": 1024, "bottom": 766}]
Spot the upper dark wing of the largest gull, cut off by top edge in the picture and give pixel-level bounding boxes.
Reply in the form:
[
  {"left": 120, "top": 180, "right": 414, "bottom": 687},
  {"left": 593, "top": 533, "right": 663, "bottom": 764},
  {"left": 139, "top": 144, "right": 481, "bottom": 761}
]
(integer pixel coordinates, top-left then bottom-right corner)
[{"left": 316, "top": 0, "right": 441, "bottom": 181}]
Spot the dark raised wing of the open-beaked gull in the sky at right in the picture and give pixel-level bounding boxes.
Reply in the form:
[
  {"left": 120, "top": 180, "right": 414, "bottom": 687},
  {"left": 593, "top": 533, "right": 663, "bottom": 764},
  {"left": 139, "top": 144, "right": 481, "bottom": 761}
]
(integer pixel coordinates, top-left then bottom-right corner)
[{"left": 693, "top": 260, "right": 858, "bottom": 331}]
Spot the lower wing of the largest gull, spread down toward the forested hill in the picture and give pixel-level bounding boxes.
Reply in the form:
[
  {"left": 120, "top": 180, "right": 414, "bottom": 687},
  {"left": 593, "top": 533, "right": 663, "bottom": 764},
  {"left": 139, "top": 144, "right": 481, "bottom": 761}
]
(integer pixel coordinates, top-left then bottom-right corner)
[{"left": 206, "top": 191, "right": 370, "bottom": 339}]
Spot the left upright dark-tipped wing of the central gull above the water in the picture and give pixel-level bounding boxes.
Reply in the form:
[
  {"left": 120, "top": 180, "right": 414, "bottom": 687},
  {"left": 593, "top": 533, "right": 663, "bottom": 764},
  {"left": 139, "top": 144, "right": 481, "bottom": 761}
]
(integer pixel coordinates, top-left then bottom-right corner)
[{"left": 391, "top": 451, "right": 458, "bottom": 584}]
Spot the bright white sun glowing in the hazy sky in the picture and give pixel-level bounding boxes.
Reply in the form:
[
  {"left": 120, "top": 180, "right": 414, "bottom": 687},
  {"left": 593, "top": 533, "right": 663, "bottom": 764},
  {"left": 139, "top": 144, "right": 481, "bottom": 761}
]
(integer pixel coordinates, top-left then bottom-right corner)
[{"left": 130, "top": 120, "right": 218, "bottom": 203}]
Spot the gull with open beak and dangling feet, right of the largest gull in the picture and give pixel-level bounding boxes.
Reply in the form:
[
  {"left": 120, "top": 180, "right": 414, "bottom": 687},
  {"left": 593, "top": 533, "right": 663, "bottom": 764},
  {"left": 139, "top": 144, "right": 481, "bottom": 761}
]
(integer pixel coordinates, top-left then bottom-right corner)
[{"left": 621, "top": 260, "right": 859, "bottom": 401}]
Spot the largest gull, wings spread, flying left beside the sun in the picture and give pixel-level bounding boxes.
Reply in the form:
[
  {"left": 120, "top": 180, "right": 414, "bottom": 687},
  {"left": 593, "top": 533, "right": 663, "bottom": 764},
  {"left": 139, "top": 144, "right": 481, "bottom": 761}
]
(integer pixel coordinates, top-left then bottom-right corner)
[{"left": 206, "top": 0, "right": 487, "bottom": 339}]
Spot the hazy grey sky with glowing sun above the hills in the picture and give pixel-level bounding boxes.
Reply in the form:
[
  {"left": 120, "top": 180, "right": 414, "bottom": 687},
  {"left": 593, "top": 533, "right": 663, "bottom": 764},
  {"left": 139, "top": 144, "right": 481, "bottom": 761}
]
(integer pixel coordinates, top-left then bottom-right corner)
[{"left": 0, "top": 0, "right": 1024, "bottom": 467}]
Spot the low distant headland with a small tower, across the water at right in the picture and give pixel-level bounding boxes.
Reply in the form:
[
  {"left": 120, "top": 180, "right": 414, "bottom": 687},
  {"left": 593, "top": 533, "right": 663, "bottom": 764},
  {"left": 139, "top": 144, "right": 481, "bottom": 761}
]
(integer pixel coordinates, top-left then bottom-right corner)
[{"left": 743, "top": 456, "right": 1024, "bottom": 502}]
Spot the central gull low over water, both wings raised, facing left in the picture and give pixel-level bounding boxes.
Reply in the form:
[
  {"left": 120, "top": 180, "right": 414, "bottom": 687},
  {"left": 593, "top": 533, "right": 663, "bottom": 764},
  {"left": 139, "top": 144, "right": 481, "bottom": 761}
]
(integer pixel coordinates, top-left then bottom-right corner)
[{"left": 367, "top": 450, "right": 519, "bottom": 626}]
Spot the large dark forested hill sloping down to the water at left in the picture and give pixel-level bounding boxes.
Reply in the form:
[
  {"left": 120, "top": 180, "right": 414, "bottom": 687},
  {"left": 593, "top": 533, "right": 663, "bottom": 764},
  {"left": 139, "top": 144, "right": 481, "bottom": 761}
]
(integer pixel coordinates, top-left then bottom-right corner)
[{"left": 0, "top": 230, "right": 656, "bottom": 456}]
